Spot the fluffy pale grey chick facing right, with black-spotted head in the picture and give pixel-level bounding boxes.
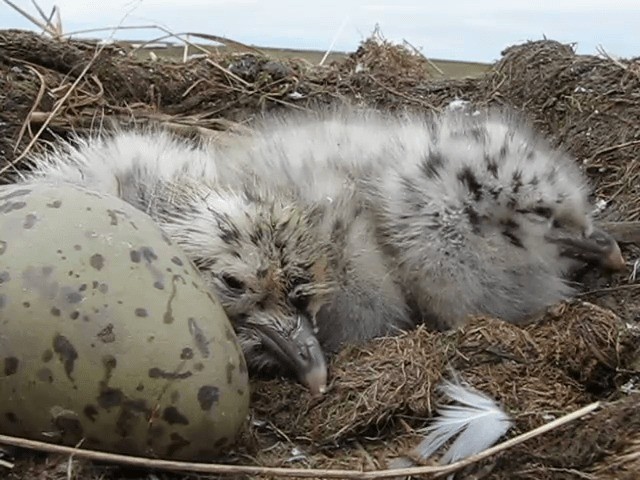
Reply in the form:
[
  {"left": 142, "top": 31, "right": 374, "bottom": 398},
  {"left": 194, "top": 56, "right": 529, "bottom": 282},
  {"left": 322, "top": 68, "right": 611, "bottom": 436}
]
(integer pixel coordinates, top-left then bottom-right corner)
[{"left": 225, "top": 112, "right": 621, "bottom": 336}]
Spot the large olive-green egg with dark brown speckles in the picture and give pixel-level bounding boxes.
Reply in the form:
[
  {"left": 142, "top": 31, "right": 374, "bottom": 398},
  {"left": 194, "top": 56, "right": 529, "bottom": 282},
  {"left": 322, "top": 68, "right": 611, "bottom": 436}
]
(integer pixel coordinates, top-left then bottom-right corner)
[{"left": 0, "top": 184, "right": 249, "bottom": 461}]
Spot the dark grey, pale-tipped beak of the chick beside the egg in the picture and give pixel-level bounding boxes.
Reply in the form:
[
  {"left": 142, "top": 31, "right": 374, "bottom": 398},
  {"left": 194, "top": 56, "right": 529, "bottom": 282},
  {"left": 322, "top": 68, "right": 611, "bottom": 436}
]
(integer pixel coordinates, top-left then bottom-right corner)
[{"left": 260, "top": 315, "right": 327, "bottom": 396}]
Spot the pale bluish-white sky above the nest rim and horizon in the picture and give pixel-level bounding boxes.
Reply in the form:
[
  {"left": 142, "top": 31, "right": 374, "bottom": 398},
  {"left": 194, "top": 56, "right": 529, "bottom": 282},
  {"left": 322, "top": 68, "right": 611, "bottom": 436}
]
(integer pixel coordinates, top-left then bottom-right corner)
[{"left": 0, "top": 0, "right": 640, "bottom": 62}]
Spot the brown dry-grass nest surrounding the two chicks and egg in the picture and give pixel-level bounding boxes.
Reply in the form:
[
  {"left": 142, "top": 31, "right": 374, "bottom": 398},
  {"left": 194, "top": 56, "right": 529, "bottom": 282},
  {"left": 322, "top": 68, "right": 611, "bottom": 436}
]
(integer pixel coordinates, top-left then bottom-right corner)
[{"left": 0, "top": 31, "right": 640, "bottom": 480}]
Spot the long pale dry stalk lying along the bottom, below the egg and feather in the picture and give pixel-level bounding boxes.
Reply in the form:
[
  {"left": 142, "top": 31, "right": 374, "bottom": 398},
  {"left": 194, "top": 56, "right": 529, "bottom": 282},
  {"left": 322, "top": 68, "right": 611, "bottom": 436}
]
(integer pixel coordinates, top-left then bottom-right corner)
[{"left": 0, "top": 402, "right": 601, "bottom": 480}]
